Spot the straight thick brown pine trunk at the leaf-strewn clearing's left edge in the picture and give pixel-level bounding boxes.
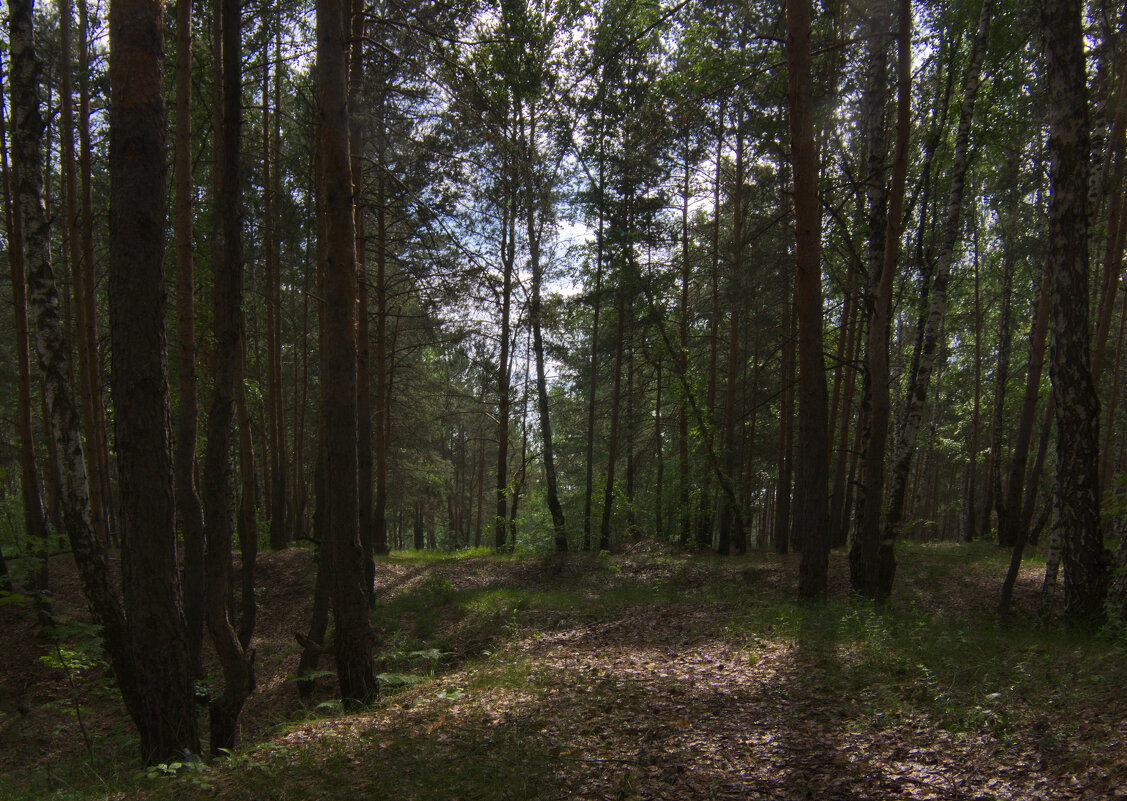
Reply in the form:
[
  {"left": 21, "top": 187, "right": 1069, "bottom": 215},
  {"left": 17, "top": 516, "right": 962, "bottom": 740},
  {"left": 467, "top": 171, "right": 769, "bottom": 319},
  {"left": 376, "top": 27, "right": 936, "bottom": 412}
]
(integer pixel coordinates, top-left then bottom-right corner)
[{"left": 317, "top": 0, "right": 379, "bottom": 709}]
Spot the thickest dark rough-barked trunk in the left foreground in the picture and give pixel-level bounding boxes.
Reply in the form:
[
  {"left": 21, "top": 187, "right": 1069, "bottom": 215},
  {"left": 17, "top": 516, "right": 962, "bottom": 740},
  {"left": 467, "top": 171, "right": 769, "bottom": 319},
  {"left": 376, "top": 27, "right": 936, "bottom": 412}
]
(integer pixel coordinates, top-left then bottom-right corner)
[{"left": 109, "top": 0, "right": 199, "bottom": 763}]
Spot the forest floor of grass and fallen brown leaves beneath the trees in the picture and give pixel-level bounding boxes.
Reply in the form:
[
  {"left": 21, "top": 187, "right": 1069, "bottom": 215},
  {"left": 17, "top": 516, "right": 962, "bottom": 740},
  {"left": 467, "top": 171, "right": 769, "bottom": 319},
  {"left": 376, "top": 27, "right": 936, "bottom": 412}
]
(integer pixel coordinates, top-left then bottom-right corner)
[{"left": 0, "top": 541, "right": 1127, "bottom": 801}]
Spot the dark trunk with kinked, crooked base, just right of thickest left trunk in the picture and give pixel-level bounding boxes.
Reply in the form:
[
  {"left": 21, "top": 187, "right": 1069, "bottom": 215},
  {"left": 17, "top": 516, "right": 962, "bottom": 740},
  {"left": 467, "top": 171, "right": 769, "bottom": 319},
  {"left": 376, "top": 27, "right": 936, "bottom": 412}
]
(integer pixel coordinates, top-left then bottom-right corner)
[{"left": 203, "top": 0, "right": 255, "bottom": 754}]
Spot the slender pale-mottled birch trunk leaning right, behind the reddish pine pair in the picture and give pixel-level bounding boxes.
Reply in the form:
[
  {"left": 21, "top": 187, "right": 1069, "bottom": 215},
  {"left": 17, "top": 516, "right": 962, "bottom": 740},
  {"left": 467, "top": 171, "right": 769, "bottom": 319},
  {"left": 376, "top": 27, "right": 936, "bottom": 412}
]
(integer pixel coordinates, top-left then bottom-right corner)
[{"left": 879, "top": 0, "right": 994, "bottom": 597}]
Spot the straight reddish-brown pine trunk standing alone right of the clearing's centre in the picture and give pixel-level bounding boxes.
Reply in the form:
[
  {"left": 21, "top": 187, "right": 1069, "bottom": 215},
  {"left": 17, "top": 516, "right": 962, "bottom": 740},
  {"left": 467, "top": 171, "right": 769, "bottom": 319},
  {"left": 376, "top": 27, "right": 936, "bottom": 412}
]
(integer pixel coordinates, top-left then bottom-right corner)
[{"left": 787, "top": 0, "right": 829, "bottom": 599}]
